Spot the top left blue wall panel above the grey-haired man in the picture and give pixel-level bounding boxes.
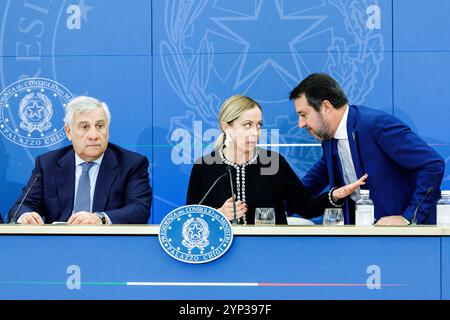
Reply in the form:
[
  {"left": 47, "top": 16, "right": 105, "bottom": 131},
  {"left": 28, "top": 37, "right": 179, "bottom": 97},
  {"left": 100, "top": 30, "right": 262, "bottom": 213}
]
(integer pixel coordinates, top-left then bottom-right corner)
[{"left": 0, "top": 0, "right": 151, "bottom": 57}]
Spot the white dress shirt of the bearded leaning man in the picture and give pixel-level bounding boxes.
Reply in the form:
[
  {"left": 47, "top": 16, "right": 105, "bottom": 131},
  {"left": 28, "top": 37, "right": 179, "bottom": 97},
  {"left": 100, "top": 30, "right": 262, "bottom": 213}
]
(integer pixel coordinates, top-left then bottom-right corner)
[{"left": 334, "top": 105, "right": 360, "bottom": 201}]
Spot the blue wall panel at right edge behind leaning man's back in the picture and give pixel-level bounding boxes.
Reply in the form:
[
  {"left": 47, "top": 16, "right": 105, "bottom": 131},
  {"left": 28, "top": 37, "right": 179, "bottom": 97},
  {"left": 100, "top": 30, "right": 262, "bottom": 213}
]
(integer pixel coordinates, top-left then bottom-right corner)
[{"left": 394, "top": 52, "right": 450, "bottom": 189}]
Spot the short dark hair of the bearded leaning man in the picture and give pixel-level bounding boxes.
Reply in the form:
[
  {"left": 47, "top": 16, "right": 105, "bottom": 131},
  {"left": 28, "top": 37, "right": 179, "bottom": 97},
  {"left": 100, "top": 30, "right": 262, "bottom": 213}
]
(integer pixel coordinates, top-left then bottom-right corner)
[{"left": 289, "top": 73, "right": 348, "bottom": 112}]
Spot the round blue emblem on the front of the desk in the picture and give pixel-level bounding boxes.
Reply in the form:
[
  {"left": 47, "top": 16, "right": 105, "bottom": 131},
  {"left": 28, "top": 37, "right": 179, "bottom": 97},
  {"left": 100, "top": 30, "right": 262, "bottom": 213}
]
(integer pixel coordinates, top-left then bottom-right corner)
[{"left": 159, "top": 205, "right": 233, "bottom": 263}]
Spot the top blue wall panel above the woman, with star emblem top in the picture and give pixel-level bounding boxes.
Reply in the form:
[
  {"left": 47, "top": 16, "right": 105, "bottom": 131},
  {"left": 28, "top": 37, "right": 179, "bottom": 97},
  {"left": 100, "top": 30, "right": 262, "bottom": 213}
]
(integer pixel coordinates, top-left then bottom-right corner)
[{"left": 153, "top": 0, "right": 392, "bottom": 54}]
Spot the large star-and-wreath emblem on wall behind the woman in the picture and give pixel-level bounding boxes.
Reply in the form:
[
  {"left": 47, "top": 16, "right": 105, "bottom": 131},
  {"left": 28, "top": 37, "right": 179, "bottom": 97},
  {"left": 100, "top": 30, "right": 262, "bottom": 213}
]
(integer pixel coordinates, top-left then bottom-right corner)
[{"left": 159, "top": 0, "right": 385, "bottom": 175}]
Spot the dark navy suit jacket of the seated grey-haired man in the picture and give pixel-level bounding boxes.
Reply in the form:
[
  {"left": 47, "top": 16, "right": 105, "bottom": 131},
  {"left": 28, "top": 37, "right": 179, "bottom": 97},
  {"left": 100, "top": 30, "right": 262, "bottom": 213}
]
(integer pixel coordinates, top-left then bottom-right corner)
[{"left": 9, "top": 143, "right": 152, "bottom": 224}]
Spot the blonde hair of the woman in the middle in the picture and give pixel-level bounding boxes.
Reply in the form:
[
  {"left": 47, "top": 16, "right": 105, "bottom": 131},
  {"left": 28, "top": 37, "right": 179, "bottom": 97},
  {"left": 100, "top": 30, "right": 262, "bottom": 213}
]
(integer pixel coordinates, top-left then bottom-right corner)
[{"left": 214, "top": 95, "right": 262, "bottom": 150}]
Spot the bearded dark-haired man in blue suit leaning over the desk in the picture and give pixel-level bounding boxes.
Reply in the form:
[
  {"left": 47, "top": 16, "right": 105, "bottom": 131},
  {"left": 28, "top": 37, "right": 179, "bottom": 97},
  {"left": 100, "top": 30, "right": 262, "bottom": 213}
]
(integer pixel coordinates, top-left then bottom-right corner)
[{"left": 290, "top": 73, "right": 445, "bottom": 225}]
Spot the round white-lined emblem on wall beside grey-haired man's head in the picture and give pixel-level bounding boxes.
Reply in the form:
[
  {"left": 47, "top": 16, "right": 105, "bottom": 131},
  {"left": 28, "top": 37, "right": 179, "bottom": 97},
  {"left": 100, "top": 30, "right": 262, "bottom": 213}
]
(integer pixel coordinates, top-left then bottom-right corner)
[{"left": 0, "top": 78, "right": 73, "bottom": 148}]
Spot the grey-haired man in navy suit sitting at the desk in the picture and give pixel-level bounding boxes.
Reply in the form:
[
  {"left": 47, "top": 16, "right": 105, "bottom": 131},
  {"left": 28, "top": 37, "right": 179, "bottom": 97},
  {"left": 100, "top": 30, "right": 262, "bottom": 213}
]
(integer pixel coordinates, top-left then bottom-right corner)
[{"left": 9, "top": 96, "right": 152, "bottom": 224}]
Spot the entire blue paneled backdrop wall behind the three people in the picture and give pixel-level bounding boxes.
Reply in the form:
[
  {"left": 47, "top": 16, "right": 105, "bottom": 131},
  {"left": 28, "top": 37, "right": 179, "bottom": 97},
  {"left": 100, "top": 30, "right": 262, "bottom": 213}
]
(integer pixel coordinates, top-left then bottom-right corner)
[{"left": 0, "top": 0, "right": 450, "bottom": 223}]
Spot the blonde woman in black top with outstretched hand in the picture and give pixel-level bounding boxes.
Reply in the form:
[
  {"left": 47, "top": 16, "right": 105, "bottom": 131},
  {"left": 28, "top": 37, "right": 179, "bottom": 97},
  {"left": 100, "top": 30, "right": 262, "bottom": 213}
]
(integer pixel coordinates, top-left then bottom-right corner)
[{"left": 186, "top": 95, "right": 367, "bottom": 224}]
